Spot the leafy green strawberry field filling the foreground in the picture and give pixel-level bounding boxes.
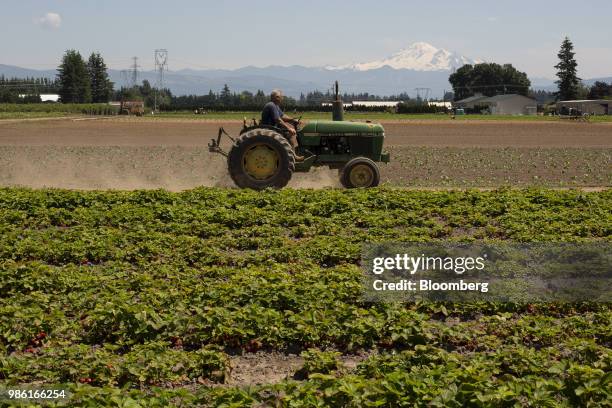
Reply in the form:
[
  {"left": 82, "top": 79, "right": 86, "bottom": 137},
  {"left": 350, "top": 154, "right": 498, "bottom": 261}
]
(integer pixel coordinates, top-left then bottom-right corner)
[{"left": 0, "top": 188, "right": 612, "bottom": 406}]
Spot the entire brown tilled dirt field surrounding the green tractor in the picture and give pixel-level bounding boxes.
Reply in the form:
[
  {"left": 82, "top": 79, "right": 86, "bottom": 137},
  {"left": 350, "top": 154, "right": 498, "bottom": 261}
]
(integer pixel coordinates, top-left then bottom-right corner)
[{"left": 0, "top": 119, "right": 612, "bottom": 190}]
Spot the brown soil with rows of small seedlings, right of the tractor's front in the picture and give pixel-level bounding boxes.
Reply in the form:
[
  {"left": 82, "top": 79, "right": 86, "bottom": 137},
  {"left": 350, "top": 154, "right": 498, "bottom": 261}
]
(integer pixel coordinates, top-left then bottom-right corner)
[{"left": 388, "top": 146, "right": 612, "bottom": 187}]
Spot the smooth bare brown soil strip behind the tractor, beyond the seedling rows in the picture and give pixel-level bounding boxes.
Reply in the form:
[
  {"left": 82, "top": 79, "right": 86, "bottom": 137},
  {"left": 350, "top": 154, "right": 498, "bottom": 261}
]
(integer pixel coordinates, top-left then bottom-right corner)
[{"left": 0, "top": 119, "right": 612, "bottom": 148}]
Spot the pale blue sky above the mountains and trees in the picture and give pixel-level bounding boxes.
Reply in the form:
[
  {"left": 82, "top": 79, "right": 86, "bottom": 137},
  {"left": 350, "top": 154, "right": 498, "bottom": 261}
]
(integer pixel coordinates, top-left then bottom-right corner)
[{"left": 0, "top": 0, "right": 612, "bottom": 78}]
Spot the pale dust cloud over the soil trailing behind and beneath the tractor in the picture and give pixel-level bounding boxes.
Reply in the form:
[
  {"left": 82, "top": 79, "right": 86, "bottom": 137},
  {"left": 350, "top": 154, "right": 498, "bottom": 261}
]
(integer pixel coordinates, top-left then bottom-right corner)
[{"left": 0, "top": 146, "right": 340, "bottom": 191}]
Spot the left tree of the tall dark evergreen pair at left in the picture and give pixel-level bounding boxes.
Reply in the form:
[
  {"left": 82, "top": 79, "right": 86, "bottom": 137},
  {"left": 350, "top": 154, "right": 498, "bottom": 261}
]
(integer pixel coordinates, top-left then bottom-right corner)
[{"left": 57, "top": 50, "right": 91, "bottom": 103}]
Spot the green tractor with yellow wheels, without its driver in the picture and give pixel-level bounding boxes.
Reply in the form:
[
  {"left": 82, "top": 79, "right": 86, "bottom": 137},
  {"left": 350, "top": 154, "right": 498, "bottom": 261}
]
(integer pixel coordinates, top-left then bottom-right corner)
[{"left": 208, "top": 82, "right": 389, "bottom": 190}]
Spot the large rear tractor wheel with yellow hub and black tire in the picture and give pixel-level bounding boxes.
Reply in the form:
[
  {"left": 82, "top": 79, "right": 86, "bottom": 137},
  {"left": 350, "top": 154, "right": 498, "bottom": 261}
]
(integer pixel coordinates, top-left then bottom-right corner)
[{"left": 227, "top": 129, "right": 295, "bottom": 190}]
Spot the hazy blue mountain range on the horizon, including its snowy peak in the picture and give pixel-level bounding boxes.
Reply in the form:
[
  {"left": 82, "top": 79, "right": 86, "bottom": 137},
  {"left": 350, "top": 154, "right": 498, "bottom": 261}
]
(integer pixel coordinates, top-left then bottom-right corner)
[{"left": 0, "top": 42, "right": 612, "bottom": 97}]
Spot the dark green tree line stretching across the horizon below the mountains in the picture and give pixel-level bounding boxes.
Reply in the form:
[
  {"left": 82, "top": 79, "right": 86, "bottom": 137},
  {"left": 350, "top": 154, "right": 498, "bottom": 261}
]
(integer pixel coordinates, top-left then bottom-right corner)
[{"left": 0, "top": 41, "right": 612, "bottom": 110}]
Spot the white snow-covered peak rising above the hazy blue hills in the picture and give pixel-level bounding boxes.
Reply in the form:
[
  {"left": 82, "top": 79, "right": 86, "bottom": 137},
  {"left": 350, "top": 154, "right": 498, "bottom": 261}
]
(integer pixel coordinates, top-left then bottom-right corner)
[{"left": 327, "top": 42, "right": 483, "bottom": 71}]
